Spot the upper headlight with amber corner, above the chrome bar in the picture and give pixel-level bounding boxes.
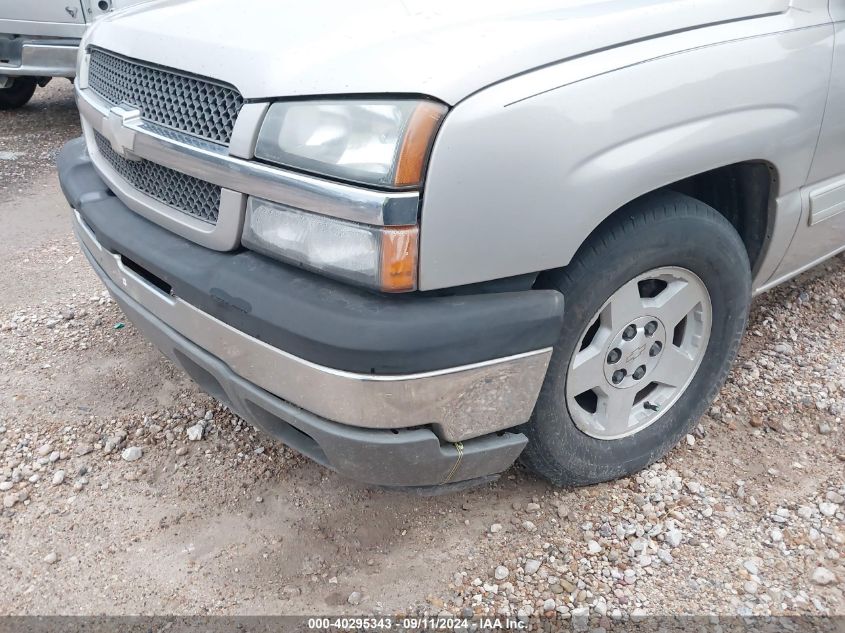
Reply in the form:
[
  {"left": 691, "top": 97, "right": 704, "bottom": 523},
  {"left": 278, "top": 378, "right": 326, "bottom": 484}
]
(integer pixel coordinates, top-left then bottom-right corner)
[{"left": 255, "top": 99, "right": 446, "bottom": 188}]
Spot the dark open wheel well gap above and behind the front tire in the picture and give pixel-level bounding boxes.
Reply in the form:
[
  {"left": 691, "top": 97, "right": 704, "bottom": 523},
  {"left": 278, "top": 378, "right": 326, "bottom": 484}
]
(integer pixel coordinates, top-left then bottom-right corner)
[{"left": 664, "top": 161, "right": 777, "bottom": 270}]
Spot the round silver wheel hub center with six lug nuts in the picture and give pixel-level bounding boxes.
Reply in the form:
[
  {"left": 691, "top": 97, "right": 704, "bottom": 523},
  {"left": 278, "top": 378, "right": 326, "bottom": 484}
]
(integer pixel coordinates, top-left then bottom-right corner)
[{"left": 604, "top": 316, "right": 666, "bottom": 389}]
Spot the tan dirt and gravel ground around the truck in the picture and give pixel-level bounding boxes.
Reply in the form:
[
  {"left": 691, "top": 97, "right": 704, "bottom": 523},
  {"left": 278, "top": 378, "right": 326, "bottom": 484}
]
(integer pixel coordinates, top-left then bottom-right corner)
[{"left": 0, "top": 84, "right": 845, "bottom": 628}]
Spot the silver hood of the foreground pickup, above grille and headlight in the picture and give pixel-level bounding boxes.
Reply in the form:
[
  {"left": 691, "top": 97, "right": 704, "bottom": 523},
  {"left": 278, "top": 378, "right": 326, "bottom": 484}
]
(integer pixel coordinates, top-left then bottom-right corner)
[{"left": 90, "top": 0, "right": 789, "bottom": 104}]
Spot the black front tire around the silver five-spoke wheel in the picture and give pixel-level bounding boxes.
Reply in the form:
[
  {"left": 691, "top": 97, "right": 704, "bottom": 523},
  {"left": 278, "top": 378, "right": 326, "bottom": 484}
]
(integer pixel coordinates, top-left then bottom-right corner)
[{"left": 521, "top": 191, "right": 751, "bottom": 486}]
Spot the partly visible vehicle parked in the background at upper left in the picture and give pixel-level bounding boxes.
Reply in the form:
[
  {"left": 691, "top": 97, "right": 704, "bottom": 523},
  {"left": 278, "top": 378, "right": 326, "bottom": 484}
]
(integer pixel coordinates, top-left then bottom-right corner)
[{"left": 0, "top": 0, "right": 142, "bottom": 110}]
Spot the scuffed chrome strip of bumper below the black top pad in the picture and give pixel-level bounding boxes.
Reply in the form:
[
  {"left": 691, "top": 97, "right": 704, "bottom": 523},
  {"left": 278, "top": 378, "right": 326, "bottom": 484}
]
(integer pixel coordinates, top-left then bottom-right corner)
[{"left": 74, "top": 212, "right": 552, "bottom": 442}]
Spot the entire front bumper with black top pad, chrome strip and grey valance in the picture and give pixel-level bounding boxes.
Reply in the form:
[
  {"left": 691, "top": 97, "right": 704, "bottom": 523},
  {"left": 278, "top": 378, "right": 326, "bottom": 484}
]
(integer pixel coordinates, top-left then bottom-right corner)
[{"left": 58, "top": 141, "right": 563, "bottom": 486}]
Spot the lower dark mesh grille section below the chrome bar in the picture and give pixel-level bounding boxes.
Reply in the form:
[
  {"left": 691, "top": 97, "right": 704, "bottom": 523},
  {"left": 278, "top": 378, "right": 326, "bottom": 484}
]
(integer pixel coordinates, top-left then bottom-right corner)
[{"left": 94, "top": 132, "right": 220, "bottom": 224}]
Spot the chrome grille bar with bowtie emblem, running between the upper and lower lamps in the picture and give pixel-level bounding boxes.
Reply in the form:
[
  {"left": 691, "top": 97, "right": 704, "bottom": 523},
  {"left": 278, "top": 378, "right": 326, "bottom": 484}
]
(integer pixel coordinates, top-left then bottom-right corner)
[{"left": 76, "top": 87, "right": 419, "bottom": 232}]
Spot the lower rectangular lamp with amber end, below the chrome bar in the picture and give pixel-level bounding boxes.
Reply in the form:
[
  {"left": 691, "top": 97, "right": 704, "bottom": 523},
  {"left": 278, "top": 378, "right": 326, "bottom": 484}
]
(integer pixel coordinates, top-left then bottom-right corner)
[{"left": 242, "top": 198, "right": 418, "bottom": 292}]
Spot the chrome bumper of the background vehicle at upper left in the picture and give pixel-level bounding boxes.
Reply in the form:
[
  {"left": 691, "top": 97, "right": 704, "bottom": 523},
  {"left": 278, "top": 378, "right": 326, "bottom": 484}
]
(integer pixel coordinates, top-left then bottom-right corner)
[{"left": 0, "top": 38, "right": 79, "bottom": 78}]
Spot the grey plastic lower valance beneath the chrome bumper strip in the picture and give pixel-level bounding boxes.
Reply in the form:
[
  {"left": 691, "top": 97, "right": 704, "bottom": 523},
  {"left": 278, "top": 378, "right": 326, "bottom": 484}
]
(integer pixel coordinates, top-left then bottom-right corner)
[{"left": 90, "top": 260, "right": 527, "bottom": 488}]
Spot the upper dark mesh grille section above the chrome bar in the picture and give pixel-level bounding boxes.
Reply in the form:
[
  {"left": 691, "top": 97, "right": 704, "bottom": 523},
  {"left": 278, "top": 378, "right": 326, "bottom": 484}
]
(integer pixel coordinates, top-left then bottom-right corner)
[{"left": 88, "top": 49, "right": 244, "bottom": 145}]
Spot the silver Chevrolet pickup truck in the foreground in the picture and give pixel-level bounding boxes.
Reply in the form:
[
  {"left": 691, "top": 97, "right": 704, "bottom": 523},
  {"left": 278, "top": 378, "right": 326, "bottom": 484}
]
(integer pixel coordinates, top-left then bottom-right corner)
[{"left": 58, "top": 0, "right": 845, "bottom": 488}]
